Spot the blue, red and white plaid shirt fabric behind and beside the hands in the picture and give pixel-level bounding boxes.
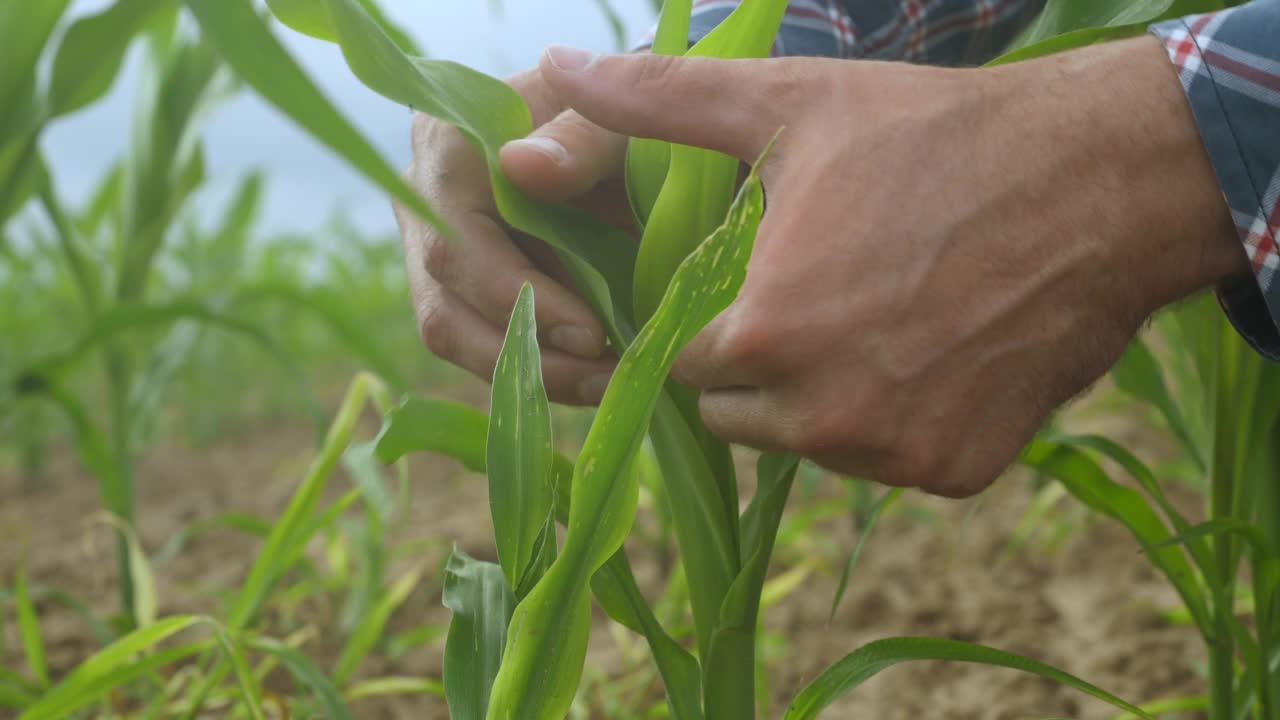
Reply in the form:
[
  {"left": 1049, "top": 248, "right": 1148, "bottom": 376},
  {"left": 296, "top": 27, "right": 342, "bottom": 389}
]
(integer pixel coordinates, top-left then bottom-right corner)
[{"left": 675, "top": 0, "right": 1280, "bottom": 360}]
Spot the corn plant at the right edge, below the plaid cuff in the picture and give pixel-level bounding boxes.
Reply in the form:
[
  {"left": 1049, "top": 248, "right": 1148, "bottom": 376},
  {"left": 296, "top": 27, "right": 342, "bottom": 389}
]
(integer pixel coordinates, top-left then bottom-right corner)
[{"left": 1023, "top": 286, "right": 1280, "bottom": 720}]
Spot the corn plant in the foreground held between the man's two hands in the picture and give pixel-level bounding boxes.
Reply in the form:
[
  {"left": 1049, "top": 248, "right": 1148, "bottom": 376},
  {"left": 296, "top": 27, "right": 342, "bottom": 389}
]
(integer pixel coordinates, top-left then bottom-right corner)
[{"left": 175, "top": 0, "right": 1280, "bottom": 719}]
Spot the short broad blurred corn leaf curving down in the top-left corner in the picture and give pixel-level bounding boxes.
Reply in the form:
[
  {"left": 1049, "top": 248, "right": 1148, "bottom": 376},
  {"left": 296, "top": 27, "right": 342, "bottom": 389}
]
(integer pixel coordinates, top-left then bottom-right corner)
[{"left": 49, "top": 0, "right": 178, "bottom": 115}]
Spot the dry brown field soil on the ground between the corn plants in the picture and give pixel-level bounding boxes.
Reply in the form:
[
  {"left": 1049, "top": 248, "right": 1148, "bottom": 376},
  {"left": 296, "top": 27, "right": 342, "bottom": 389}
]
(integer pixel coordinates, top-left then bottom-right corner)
[{"left": 0, "top": 386, "right": 1203, "bottom": 720}]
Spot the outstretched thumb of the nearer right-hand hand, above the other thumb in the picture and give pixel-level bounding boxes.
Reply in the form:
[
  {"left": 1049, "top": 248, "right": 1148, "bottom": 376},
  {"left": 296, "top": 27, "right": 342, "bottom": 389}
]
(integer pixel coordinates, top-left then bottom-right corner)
[{"left": 540, "top": 46, "right": 785, "bottom": 163}]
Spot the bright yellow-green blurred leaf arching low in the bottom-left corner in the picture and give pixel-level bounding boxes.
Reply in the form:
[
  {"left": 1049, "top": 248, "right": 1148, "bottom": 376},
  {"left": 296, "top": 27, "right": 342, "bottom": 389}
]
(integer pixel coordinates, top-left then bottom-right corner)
[{"left": 19, "top": 615, "right": 212, "bottom": 720}]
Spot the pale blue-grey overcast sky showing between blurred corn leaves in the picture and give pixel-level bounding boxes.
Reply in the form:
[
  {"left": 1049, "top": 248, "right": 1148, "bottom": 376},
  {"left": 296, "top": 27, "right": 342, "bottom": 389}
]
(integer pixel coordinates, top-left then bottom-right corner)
[{"left": 43, "top": 0, "right": 652, "bottom": 232}]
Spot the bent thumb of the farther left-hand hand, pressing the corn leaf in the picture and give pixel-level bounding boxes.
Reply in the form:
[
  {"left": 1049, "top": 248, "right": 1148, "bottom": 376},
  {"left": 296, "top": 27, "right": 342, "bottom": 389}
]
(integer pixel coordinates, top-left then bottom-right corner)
[{"left": 500, "top": 105, "right": 627, "bottom": 201}]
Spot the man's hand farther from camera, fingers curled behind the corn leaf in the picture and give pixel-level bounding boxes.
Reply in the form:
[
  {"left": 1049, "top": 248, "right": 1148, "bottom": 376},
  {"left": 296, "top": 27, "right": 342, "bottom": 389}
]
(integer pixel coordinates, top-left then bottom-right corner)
[{"left": 396, "top": 70, "right": 630, "bottom": 405}]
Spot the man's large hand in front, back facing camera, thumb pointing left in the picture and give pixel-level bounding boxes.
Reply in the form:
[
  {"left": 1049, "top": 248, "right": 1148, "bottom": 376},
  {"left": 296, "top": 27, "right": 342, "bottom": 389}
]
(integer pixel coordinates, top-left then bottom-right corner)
[{"left": 541, "top": 38, "right": 1247, "bottom": 496}]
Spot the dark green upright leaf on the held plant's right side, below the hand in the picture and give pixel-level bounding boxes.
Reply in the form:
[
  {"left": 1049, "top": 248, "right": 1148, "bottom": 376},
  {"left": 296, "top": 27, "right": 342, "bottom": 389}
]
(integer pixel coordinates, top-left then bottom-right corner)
[{"left": 706, "top": 454, "right": 800, "bottom": 720}]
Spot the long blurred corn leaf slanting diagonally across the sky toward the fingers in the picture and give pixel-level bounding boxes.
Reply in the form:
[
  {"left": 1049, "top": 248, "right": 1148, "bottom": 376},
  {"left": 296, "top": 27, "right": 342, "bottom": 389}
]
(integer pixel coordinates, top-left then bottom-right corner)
[{"left": 186, "top": 0, "right": 453, "bottom": 236}]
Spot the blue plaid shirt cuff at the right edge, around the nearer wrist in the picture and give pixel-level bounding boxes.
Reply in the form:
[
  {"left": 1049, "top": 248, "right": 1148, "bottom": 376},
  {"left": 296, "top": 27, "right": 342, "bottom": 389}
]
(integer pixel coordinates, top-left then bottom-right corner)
[{"left": 1152, "top": 0, "right": 1280, "bottom": 360}]
